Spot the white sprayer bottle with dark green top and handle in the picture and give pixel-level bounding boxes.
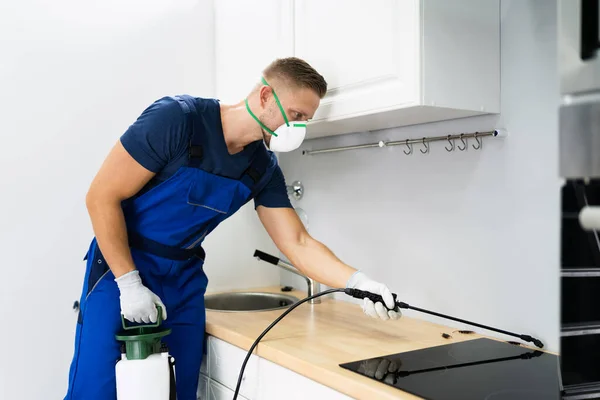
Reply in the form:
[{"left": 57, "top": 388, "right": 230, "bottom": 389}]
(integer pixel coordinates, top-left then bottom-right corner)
[{"left": 115, "top": 307, "right": 176, "bottom": 400}]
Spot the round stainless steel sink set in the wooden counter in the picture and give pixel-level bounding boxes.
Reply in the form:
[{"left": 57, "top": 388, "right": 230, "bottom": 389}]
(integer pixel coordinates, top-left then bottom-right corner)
[{"left": 204, "top": 292, "right": 299, "bottom": 312}]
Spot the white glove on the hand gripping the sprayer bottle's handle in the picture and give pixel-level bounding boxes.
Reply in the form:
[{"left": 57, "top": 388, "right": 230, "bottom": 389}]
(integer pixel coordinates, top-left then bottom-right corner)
[{"left": 115, "top": 270, "right": 167, "bottom": 323}]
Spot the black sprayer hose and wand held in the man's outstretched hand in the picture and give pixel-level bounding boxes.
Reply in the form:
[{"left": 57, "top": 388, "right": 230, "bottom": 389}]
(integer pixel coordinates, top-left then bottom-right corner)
[{"left": 233, "top": 288, "right": 544, "bottom": 400}]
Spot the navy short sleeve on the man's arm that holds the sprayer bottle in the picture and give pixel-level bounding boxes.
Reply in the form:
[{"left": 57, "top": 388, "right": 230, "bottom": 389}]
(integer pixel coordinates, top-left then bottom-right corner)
[{"left": 121, "top": 97, "right": 187, "bottom": 173}]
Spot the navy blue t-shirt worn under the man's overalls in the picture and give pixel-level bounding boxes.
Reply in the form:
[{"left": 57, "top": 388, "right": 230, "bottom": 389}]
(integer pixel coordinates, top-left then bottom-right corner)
[{"left": 121, "top": 97, "right": 292, "bottom": 208}]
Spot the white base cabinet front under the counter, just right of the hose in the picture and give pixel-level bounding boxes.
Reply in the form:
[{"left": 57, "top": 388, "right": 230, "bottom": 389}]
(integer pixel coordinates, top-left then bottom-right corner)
[{"left": 257, "top": 358, "right": 352, "bottom": 400}]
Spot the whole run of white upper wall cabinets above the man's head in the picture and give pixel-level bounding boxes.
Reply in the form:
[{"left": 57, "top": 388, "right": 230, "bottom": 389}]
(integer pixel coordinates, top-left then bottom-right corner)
[{"left": 215, "top": 0, "right": 500, "bottom": 138}]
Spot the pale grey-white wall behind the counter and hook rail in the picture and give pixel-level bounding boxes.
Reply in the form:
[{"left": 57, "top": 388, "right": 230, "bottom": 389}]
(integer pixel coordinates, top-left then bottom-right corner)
[{"left": 281, "top": 0, "right": 561, "bottom": 351}]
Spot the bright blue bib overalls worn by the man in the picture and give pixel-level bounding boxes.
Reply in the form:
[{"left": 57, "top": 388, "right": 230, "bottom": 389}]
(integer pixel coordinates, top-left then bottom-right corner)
[{"left": 65, "top": 96, "right": 277, "bottom": 400}]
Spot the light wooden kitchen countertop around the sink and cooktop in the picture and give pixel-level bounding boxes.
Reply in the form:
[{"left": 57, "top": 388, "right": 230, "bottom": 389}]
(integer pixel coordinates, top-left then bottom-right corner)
[{"left": 206, "top": 287, "right": 504, "bottom": 400}]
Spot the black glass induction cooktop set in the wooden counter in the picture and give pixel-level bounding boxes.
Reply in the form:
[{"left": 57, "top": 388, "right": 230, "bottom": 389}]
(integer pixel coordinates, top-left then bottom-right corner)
[{"left": 340, "top": 338, "right": 561, "bottom": 400}]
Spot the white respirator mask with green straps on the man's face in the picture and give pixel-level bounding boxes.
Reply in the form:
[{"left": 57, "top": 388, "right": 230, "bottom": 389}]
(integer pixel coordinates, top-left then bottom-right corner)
[{"left": 246, "top": 77, "right": 306, "bottom": 153}]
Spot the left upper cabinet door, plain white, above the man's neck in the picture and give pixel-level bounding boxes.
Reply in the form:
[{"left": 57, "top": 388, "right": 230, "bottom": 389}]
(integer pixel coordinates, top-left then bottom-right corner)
[{"left": 214, "top": 0, "right": 294, "bottom": 103}]
